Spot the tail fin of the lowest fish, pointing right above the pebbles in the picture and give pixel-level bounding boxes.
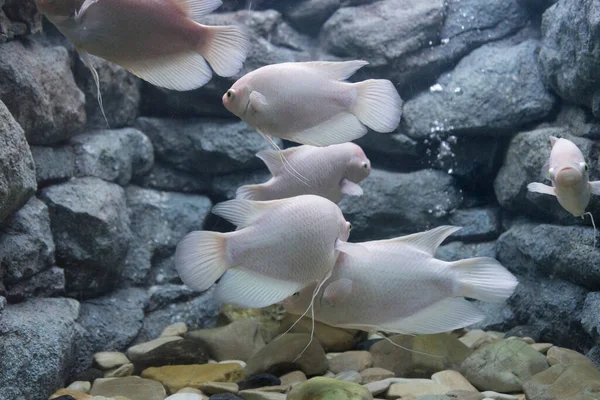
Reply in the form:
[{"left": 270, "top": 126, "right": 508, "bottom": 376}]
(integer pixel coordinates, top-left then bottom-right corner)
[{"left": 452, "top": 257, "right": 518, "bottom": 303}]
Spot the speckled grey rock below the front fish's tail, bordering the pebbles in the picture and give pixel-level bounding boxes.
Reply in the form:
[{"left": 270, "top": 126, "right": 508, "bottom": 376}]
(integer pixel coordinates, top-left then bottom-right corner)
[{"left": 136, "top": 290, "right": 221, "bottom": 343}]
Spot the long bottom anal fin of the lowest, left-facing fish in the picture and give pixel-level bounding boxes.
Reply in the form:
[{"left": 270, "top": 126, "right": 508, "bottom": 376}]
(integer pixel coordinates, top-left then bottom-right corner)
[{"left": 381, "top": 297, "right": 485, "bottom": 335}]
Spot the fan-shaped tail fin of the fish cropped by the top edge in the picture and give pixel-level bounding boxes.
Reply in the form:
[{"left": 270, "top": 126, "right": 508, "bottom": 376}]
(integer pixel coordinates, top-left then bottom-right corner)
[{"left": 197, "top": 25, "right": 250, "bottom": 76}]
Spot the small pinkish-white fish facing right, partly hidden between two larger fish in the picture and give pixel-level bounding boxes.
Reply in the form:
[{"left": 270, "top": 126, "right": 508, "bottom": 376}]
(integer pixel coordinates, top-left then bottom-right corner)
[{"left": 237, "top": 143, "right": 371, "bottom": 203}]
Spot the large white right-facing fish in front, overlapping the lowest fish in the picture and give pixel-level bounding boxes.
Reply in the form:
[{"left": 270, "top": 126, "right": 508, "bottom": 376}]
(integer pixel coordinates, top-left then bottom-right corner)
[{"left": 175, "top": 195, "right": 350, "bottom": 308}]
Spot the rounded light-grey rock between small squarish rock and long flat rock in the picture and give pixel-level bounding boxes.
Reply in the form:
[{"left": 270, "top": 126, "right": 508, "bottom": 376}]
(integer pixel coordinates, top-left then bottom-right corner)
[{"left": 71, "top": 128, "right": 154, "bottom": 185}]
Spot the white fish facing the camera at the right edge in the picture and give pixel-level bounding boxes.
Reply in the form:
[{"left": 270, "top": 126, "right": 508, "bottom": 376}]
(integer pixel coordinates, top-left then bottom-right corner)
[{"left": 527, "top": 136, "right": 600, "bottom": 217}]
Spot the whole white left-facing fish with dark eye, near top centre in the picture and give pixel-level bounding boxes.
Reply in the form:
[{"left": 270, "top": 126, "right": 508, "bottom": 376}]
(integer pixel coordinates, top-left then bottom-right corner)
[{"left": 223, "top": 60, "right": 402, "bottom": 146}]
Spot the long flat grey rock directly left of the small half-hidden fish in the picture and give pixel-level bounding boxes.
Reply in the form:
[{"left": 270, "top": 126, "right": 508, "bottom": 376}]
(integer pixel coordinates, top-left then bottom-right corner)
[{"left": 137, "top": 118, "right": 281, "bottom": 176}]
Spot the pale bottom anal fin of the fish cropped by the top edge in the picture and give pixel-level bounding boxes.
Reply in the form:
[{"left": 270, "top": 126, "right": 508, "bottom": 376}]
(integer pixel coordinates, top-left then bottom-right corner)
[{"left": 113, "top": 50, "right": 212, "bottom": 91}]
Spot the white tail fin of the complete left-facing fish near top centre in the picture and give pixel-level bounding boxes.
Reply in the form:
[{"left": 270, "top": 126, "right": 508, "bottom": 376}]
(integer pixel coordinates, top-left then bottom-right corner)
[{"left": 352, "top": 79, "right": 402, "bottom": 133}]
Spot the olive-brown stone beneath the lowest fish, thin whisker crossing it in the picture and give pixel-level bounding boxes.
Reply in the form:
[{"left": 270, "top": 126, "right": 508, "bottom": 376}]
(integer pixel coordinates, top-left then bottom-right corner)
[{"left": 370, "top": 334, "right": 471, "bottom": 378}]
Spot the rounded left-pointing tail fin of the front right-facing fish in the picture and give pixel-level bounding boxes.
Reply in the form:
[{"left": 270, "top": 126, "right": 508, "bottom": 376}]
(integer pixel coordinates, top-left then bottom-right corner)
[{"left": 175, "top": 231, "right": 231, "bottom": 292}]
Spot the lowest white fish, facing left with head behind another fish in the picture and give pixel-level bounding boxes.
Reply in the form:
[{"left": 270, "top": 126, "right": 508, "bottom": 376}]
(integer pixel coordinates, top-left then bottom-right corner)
[{"left": 283, "top": 226, "right": 517, "bottom": 334}]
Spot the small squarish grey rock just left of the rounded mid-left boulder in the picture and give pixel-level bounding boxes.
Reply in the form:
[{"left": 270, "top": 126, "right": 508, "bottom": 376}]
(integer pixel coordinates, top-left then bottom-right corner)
[{"left": 31, "top": 146, "right": 75, "bottom": 186}]
